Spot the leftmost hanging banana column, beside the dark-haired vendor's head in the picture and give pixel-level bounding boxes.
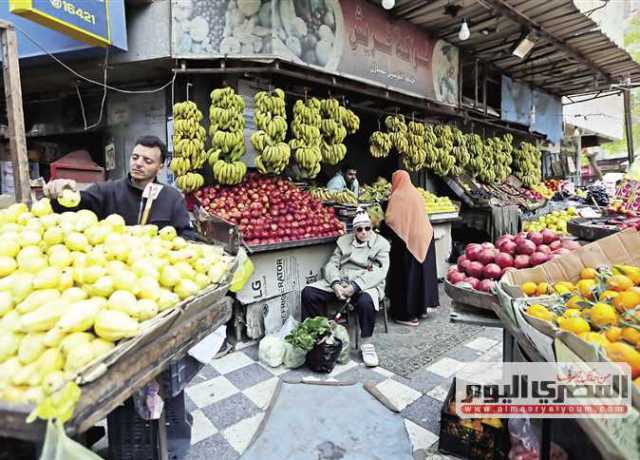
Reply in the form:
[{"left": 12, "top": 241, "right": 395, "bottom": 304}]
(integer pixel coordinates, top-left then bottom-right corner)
[{"left": 169, "top": 101, "right": 207, "bottom": 192}]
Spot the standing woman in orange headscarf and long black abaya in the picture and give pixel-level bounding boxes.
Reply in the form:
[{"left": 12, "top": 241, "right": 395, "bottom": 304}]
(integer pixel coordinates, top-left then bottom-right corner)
[{"left": 384, "top": 170, "right": 439, "bottom": 326}]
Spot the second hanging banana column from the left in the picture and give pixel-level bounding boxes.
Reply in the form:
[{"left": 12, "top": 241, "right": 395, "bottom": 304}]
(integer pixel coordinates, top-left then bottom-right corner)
[{"left": 206, "top": 87, "right": 247, "bottom": 185}]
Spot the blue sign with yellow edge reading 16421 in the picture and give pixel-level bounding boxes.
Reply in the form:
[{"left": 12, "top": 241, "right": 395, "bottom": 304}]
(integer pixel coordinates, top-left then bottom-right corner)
[{"left": 9, "top": 0, "right": 111, "bottom": 46}]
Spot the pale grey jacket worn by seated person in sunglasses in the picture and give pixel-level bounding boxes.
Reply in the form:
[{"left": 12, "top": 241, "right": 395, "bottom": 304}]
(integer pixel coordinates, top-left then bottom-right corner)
[{"left": 311, "top": 232, "right": 391, "bottom": 310}]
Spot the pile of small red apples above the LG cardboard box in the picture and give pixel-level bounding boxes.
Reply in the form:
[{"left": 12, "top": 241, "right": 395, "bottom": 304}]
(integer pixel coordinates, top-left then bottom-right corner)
[{"left": 195, "top": 174, "right": 344, "bottom": 246}]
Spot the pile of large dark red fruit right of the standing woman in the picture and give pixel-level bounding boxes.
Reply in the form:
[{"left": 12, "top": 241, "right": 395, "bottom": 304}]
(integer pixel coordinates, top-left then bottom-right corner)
[{"left": 447, "top": 229, "right": 580, "bottom": 292}]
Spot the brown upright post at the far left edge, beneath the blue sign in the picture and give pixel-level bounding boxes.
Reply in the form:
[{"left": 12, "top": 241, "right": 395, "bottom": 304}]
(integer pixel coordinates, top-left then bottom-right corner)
[{"left": 0, "top": 21, "right": 31, "bottom": 203}]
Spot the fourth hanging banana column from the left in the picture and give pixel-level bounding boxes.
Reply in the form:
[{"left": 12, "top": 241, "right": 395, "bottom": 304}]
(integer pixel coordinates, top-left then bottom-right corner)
[{"left": 289, "top": 97, "right": 322, "bottom": 179}]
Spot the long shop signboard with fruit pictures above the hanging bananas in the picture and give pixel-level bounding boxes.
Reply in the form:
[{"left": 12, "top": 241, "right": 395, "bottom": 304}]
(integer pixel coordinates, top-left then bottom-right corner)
[{"left": 172, "top": 0, "right": 459, "bottom": 105}]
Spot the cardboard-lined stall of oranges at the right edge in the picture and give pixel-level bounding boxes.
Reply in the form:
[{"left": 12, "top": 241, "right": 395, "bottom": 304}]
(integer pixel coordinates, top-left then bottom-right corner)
[{"left": 495, "top": 229, "right": 640, "bottom": 458}]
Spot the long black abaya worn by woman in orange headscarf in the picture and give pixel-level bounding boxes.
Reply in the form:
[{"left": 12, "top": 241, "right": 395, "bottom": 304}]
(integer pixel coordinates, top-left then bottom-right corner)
[{"left": 381, "top": 223, "right": 440, "bottom": 321}]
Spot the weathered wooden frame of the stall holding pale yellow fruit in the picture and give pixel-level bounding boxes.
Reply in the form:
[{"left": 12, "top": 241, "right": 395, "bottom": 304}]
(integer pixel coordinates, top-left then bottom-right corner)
[{"left": 0, "top": 297, "right": 232, "bottom": 445}]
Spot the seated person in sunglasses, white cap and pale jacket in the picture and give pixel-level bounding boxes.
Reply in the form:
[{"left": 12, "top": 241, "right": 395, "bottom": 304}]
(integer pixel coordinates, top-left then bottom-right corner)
[{"left": 302, "top": 209, "right": 391, "bottom": 367}]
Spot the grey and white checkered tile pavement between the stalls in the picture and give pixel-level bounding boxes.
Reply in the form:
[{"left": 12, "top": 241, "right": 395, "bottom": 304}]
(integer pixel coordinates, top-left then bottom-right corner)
[{"left": 185, "top": 329, "right": 502, "bottom": 460}]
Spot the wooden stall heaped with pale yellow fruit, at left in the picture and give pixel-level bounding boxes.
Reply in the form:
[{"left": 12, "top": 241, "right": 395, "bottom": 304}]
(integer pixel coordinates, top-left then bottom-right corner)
[{"left": 0, "top": 199, "right": 245, "bottom": 454}]
